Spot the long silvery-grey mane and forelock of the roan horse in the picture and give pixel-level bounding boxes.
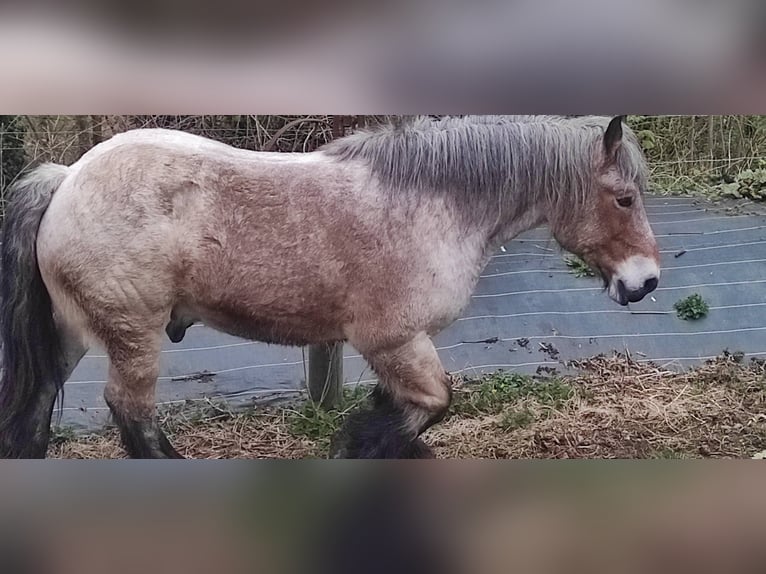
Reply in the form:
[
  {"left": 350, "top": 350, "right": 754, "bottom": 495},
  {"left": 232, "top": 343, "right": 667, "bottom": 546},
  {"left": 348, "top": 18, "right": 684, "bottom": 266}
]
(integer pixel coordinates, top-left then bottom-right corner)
[{"left": 322, "top": 116, "right": 646, "bottom": 225}]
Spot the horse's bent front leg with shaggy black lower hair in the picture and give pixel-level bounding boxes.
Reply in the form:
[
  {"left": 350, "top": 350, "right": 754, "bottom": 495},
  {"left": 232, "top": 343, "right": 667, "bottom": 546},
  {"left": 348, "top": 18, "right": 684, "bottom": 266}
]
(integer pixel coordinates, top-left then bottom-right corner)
[{"left": 330, "top": 333, "right": 452, "bottom": 459}]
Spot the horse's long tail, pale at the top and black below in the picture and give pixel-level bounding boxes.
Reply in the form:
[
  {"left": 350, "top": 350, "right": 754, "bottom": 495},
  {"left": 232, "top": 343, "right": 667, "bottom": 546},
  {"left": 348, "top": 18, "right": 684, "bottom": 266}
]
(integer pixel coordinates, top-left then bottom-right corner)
[{"left": 0, "top": 164, "right": 68, "bottom": 458}]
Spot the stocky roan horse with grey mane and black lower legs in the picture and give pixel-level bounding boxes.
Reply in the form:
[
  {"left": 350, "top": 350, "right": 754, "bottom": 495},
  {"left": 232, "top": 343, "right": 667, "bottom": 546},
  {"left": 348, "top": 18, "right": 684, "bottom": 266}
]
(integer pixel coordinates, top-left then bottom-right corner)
[{"left": 0, "top": 116, "right": 660, "bottom": 458}]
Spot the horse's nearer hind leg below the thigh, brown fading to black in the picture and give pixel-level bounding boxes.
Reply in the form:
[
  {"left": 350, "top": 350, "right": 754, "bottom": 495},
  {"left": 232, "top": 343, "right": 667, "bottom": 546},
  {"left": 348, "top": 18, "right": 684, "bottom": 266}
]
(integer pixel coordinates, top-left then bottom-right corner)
[{"left": 104, "top": 331, "right": 183, "bottom": 458}]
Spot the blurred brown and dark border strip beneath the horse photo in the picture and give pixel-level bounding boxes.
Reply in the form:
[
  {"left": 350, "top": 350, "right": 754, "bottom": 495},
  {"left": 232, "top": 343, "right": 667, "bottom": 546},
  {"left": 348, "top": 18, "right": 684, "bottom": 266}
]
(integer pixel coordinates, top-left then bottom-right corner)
[{"left": 0, "top": 461, "right": 766, "bottom": 574}]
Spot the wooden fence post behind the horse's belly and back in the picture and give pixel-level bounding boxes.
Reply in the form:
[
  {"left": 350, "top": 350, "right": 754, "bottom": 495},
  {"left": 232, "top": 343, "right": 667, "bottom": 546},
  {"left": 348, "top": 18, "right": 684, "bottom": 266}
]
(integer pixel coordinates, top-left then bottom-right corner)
[{"left": 306, "top": 116, "right": 345, "bottom": 409}]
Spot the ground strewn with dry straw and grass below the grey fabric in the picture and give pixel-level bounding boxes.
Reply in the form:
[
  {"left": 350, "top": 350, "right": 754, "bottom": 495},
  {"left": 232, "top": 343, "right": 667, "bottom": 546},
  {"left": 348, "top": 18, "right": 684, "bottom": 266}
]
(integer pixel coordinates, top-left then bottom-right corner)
[{"left": 49, "top": 353, "right": 766, "bottom": 459}]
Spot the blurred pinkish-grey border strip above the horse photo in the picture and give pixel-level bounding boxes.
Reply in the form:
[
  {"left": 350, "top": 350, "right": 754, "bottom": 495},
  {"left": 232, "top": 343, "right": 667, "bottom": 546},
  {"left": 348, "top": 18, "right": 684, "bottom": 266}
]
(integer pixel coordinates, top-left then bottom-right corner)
[{"left": 0, "top": 0, "right": 766, "bottom": 114}]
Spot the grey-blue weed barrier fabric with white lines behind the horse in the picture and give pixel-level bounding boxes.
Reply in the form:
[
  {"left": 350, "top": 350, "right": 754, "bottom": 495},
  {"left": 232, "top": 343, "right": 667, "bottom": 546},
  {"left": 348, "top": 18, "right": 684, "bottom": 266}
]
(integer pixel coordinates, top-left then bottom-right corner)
[{"left": 61, "top": 197, "right": 766, "bottom": 430}]
